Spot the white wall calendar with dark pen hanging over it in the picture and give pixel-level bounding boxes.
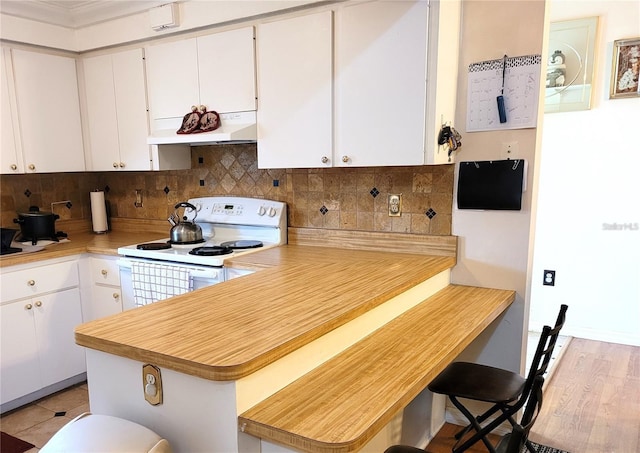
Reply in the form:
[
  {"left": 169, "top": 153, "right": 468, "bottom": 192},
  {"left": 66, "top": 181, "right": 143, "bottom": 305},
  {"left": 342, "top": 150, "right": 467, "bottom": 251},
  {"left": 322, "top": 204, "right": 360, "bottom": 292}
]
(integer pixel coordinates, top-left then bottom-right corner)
[{"left": 467, "top": 55, "right": 542, "bottom": 132}]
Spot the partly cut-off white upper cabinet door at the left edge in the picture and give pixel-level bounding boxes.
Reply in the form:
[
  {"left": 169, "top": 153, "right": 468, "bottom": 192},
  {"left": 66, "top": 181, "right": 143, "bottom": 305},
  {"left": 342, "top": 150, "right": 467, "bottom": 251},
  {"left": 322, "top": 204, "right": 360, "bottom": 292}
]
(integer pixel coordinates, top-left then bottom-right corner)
[{"left": 0, "top": 49, "right": 24, "bottom": 174}]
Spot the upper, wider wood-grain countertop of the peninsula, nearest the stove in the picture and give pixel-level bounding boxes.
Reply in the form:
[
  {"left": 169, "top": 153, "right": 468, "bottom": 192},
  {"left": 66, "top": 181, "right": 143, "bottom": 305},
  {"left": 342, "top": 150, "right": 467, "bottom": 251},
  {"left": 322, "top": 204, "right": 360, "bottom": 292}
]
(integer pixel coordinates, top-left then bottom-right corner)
[{"left": 76, "top": 245, "right": 455, "bottom": 380}]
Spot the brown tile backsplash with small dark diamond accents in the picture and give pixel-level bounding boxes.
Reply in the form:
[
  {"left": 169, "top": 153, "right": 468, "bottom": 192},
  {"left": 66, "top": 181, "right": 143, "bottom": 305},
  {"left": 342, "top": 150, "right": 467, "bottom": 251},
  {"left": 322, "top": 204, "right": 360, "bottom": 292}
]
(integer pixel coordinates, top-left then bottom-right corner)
[{"left": 0, "top": 144, "right": 454, "bottom": 235}]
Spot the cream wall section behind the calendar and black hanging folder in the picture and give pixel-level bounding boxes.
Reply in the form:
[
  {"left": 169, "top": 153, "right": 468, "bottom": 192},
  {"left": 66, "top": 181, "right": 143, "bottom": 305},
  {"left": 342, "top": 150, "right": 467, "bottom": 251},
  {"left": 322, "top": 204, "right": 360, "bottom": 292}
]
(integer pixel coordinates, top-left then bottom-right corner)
[{"left": 452, "top": 0, "right": 545, "bottom": 371}]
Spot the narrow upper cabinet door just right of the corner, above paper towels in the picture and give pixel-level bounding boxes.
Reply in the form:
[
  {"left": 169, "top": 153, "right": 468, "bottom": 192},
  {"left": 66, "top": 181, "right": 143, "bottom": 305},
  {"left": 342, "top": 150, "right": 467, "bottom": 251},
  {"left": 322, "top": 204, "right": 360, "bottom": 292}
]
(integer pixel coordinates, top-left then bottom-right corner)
[{"left": 82, "top": 55, "right": 120, "bottom": 171}]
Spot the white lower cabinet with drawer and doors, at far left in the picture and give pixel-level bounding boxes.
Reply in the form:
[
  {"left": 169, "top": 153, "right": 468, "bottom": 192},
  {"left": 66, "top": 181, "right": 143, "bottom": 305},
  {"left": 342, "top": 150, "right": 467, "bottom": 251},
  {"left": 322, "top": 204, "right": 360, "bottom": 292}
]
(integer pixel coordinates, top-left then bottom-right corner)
[{"left": 0, "top": 260, "right": 86, "bottom": 411}]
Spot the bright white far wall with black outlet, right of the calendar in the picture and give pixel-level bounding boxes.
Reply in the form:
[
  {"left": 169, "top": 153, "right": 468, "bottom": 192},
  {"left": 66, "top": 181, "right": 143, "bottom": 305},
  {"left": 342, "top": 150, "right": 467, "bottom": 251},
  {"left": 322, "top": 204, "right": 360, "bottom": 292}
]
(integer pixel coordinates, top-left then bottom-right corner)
[{"left": 530, "top": 0, "right": 640, "bottom": 345}]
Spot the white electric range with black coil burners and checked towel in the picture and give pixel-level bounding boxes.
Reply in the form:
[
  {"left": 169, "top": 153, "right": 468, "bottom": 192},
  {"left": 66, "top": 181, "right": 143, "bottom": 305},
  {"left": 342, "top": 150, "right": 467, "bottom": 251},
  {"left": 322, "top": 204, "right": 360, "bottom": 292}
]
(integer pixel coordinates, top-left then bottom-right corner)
[{"left": 118, "top": 197, "right": 287, "bottom": 309}]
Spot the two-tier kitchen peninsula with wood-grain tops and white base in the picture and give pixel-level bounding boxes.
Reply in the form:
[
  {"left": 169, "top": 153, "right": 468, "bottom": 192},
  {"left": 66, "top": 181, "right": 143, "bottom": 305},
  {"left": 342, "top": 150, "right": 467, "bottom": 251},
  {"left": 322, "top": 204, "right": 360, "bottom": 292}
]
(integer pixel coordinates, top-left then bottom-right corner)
[{"left": 76, "top": 232, "right": 514, "bottom": 452}]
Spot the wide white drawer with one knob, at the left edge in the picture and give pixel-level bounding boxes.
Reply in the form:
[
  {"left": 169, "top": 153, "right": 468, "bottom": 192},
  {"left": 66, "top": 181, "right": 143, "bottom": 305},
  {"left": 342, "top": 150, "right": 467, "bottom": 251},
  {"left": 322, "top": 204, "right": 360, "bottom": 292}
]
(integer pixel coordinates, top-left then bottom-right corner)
[{"left": 0, "top": 261, "right": 79, "bottom": 302}]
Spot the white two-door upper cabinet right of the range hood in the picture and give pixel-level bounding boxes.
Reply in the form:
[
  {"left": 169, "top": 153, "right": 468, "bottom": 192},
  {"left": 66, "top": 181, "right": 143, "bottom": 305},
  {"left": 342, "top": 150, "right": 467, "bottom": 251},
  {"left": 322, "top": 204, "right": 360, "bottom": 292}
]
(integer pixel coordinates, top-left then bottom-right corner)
[{"left": 256, "top": 0, "right": 460, "bottom": 168}]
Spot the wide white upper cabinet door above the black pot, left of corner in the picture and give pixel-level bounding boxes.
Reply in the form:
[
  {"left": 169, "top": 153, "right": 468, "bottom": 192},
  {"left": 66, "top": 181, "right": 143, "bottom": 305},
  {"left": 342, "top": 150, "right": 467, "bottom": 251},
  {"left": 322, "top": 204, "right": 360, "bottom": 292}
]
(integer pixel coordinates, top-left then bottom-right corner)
[{"left": 12, "top": 49, "right": 85, "bottom": 173}]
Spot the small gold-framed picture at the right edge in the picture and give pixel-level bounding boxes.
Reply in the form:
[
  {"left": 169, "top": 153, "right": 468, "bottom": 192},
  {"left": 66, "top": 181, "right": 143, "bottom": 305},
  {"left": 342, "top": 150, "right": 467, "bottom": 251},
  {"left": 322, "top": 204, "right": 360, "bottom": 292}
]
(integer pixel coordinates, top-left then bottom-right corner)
[{"left": 609, "top": 38, "right": 640, "bottom": 99}]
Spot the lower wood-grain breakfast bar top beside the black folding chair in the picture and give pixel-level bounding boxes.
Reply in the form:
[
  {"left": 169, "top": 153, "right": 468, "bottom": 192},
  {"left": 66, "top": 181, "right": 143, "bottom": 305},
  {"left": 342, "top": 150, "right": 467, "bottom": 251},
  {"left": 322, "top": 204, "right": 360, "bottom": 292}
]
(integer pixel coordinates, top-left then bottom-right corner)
[{"left": 238, "top": 285, "right": 515, "bottom": 453}]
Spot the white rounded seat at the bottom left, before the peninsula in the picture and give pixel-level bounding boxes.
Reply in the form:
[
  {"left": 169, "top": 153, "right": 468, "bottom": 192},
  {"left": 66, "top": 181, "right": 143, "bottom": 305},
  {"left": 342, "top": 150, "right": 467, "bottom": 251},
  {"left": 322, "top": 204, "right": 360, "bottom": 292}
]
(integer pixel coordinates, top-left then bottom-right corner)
[{"left": 40, "top": 412, "right": 172, "bottom": 453}]
